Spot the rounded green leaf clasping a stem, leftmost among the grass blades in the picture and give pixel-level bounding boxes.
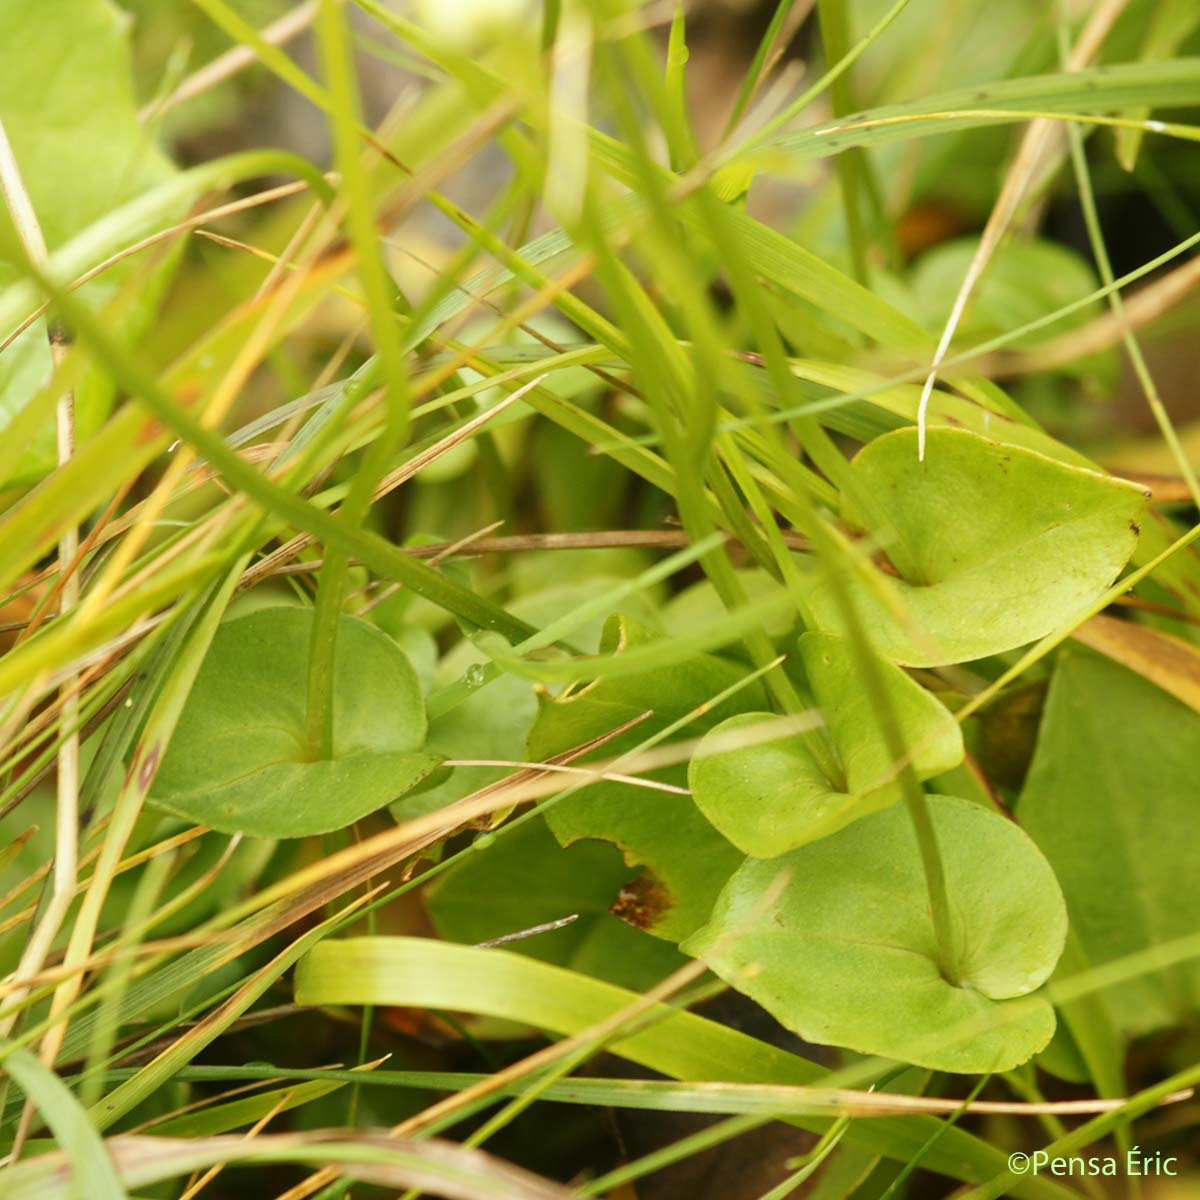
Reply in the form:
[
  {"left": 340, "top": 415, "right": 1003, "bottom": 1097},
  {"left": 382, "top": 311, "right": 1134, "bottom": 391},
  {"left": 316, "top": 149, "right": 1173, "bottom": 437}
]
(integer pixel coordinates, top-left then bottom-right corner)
[{"left": 151, "top": 607, "right": 439, "bottom": 838}]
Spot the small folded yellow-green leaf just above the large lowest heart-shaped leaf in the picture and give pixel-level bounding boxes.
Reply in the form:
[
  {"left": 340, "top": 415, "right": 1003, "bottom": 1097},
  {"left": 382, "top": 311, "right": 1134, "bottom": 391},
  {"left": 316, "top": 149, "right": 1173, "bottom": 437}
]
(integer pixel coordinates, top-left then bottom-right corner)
[{"left": 688, "top": 634, "right": 962, "bottom": 858}]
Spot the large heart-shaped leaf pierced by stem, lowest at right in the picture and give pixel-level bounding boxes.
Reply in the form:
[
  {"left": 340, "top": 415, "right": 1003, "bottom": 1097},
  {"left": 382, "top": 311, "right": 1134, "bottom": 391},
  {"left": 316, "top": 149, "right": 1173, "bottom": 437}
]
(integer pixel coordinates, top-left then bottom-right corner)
[{"left": 683, "top": 796, "right": 1067, "bottom": 1073}]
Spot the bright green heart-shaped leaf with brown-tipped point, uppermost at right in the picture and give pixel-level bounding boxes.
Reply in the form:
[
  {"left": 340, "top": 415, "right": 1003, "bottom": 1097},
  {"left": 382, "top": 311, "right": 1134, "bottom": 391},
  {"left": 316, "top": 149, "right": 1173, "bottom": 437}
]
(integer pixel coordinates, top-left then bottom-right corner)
[{"left": 805, "top": 428, "right": 1146, "bottom": 666}]
